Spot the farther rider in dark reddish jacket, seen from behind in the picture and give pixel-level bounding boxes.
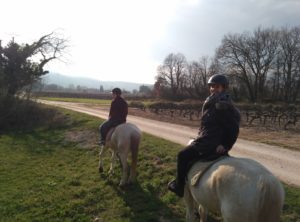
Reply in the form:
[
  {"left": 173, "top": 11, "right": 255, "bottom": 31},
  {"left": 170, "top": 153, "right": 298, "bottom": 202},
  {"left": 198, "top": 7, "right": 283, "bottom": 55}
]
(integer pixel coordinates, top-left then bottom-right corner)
[{"left": 99, "top": 88, "right": 128, "bottom": 145}]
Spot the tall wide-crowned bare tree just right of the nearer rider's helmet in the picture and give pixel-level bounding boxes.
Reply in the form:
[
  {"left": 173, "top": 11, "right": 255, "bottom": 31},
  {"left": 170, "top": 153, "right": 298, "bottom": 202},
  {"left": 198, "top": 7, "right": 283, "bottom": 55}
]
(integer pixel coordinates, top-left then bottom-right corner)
[{"left": 217, "top": 28, "right": 278, "bottom": 101}]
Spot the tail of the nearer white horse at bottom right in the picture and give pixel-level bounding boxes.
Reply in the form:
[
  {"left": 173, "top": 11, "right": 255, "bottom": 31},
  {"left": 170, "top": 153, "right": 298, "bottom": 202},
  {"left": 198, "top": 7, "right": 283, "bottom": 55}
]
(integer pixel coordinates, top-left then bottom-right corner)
[{"left": 258, "top": 175, "right": 284, "bottom": 222}]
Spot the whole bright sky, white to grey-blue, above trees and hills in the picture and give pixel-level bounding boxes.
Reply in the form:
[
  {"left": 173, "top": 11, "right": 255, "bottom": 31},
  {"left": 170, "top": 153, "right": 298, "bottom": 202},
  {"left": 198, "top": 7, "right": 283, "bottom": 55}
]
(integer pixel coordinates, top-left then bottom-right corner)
[{"left": 0, "top": 0, "right": 300, "bottom": 84}]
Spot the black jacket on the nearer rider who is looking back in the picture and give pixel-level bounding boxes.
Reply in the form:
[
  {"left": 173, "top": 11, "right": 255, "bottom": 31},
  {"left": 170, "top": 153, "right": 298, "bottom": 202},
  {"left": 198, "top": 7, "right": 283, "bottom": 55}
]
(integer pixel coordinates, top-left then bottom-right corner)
[{"left": 193, "top": 93, "right": 240, "bottom": 154}]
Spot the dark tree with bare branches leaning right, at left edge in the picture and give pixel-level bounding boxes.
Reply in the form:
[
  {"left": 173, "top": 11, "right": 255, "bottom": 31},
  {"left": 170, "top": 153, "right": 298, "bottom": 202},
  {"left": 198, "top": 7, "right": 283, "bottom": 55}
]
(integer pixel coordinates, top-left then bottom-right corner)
[{"left": 0, "top": 33, "right": 67, "bottom": 96}]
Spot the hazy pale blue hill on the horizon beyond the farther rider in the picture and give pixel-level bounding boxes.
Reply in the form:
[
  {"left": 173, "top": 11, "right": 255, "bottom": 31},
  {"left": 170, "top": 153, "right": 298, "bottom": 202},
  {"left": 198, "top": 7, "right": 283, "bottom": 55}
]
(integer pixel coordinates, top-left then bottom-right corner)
[{"left": 42, "top": 72, "right": 152, "bottom": 91}]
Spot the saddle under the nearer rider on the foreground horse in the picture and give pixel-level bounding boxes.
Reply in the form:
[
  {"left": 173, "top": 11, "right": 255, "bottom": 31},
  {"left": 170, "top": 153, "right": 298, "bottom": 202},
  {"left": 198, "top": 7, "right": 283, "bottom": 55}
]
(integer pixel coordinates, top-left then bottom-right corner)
[{"left": 189, "top": 156, "right": 229, "bottom": 186}]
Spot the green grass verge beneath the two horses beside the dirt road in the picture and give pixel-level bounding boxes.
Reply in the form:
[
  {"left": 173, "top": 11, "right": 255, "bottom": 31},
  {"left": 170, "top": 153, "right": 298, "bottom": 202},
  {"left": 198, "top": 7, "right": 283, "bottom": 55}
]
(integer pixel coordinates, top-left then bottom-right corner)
[{"left": 0, "top": 107, "right": 300, "bottom": 222}]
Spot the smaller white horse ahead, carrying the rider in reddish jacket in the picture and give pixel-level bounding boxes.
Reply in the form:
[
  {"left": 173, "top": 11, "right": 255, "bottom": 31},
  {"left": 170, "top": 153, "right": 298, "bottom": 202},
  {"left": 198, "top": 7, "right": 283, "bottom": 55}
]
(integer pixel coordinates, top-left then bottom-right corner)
[{"left": 99, "top": 123, "right": 142, "bottom": 186}]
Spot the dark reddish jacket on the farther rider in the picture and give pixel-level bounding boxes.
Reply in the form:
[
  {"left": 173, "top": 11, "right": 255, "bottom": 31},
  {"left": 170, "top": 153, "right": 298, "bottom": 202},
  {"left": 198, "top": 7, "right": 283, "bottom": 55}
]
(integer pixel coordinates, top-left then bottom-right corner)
[{"left": 109, "top": 96, "right": 128, "bottom": 123}]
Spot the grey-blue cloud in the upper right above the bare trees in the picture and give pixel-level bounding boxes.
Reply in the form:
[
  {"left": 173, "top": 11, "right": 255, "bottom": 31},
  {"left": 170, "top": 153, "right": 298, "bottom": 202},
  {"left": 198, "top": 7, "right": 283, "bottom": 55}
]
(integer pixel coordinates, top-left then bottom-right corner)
[{"left": 152, "top": 0, "right": 300, "bottom": 61}]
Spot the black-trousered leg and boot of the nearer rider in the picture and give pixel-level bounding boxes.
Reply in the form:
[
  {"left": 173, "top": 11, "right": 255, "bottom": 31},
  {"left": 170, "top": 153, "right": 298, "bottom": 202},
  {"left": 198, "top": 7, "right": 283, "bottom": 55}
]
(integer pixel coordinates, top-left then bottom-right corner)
[{"left": 168, "top": 146, "right": 200, "bottom": 197}]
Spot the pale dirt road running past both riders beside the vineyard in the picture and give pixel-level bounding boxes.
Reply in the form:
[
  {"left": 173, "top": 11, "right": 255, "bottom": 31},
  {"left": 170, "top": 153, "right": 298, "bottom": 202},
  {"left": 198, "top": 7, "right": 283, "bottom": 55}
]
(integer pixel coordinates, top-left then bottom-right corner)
[{"left": 42, "top": 101, "right": 300, "bottom": 186}]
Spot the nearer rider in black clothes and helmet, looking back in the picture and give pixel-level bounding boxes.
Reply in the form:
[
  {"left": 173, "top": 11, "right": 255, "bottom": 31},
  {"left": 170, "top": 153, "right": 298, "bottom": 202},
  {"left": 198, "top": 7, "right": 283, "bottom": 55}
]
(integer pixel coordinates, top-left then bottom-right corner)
[{"left": 168, "top": 74, "right": 240, "bottom": 197}]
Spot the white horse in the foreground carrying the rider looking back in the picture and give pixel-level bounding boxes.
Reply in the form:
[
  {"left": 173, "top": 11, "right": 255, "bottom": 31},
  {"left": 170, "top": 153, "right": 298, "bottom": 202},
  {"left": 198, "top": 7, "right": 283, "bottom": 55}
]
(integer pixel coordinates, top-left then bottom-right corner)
[{"left": 184, "top": 157, "right": 284, "bottom": 222}]
